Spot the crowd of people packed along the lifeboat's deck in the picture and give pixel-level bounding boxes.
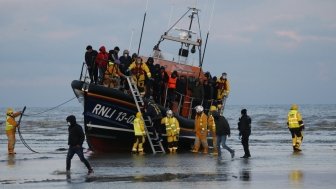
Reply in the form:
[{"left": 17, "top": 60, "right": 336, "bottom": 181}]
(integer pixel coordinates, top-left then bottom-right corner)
[{"left": 85, "top": 45, "right": 230, "bottom": 113}]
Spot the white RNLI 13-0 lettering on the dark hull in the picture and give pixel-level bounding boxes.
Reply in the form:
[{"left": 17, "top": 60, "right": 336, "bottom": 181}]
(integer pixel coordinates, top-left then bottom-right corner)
[{"left": 91, "top": 104, "right": 135, "bottom": 124}]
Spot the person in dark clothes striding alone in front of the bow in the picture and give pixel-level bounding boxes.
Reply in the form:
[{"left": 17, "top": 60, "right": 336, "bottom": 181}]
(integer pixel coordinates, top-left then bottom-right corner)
[{"left": 66, "top": 115, "right": 93, "bottom": 175}]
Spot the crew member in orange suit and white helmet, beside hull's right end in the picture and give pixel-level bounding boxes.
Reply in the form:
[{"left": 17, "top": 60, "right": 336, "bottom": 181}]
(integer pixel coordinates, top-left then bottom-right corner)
[{"left": 192, "top": 105, "right": 208, "bottom": 154}]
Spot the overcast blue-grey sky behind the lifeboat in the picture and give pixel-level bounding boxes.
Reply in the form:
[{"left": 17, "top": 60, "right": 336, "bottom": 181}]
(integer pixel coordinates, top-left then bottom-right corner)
[{"left": 0, "top": 0, "right": 336, "bottom": 107}]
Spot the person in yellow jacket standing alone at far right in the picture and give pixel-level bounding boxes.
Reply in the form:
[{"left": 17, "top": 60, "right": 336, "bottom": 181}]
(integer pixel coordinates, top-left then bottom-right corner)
[{"left": 287, "top": 104, "right": 304, "bottom": 152}]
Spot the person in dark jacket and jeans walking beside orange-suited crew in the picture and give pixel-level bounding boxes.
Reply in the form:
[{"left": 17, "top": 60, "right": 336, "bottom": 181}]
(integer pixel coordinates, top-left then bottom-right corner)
[{"left": 211, "top": 111, "right": 235, "bottom": 158}]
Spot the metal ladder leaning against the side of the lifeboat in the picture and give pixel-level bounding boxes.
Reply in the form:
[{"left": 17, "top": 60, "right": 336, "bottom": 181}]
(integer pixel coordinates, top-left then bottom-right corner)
[{"left": 126, "top": 76, "right": 166, "bottom": 154}]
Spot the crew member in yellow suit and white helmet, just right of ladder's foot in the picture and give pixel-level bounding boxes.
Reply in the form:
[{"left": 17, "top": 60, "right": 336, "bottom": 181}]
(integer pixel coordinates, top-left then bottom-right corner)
[{"left": 161, "top": 110, "right": 180, "bottom": 153}]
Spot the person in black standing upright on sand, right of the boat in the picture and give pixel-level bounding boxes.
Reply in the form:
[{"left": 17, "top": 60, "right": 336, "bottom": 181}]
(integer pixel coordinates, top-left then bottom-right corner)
[{"left": 238, "top": 109, "right": 252, "bottom": 158}]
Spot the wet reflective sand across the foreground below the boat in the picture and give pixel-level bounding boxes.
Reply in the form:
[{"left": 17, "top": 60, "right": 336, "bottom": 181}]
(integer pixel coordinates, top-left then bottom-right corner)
[{"left": 0, "top": 144, "right": 336, "bottom": 189}]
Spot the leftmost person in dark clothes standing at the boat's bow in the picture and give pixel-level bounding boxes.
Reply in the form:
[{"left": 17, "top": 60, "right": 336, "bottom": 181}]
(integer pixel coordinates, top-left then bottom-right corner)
[{"left": 85, "top": 45, "right": 98, "bottom": 84}]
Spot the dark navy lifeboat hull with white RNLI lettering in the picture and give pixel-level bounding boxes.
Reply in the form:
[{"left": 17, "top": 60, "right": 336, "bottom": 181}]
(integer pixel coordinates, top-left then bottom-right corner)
[{"left": 71, "top": 80, "right": 195, "bottom": 152}]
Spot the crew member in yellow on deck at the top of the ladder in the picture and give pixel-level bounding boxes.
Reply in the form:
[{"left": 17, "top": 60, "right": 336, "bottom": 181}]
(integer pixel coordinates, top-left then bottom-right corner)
[{"left": 128, "top": 57, "right": 152, "bottom": 96}]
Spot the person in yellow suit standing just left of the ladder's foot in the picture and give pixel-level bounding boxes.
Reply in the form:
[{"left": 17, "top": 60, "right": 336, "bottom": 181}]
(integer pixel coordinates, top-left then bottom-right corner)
[{"left": 132, "top": 112, "right": 146, "bottom": 155}]
